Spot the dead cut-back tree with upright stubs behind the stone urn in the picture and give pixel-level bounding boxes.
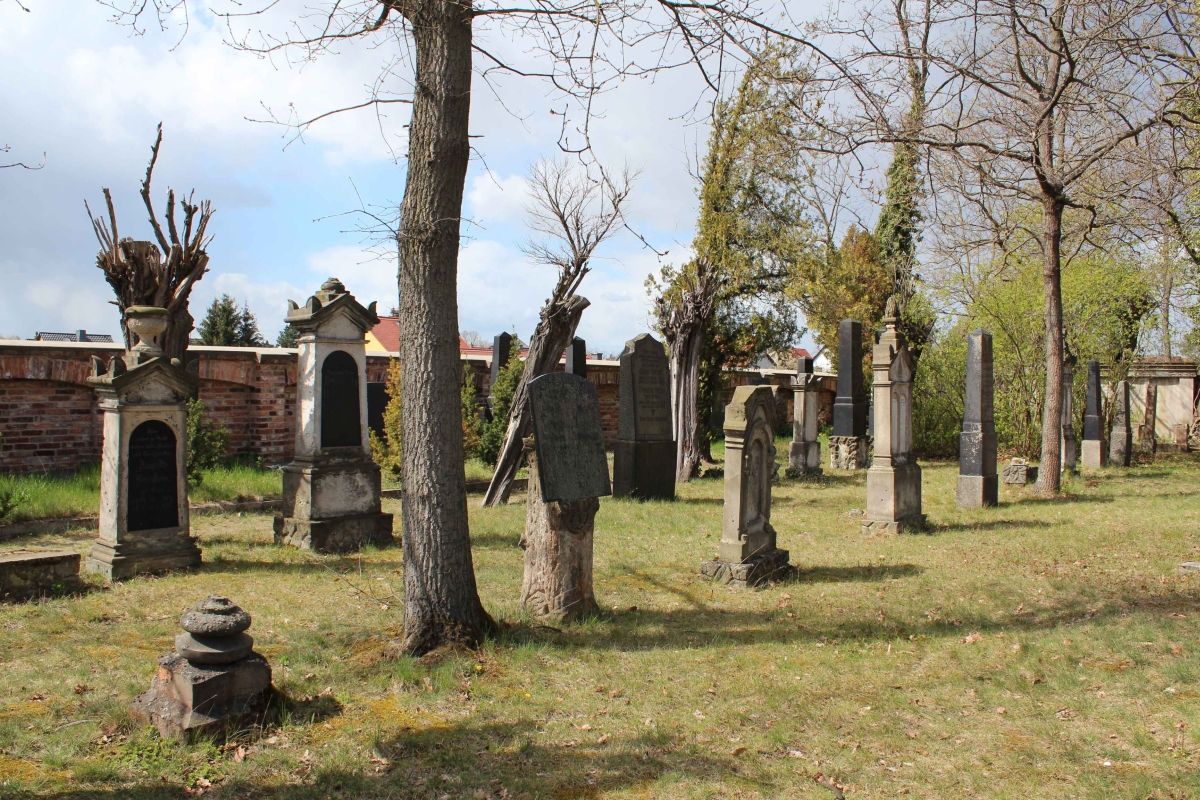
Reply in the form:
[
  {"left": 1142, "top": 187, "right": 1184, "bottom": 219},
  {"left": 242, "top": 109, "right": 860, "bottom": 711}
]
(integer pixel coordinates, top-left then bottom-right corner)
[{"left": 84, "top": 122, "right": 212, "bottom": 359}]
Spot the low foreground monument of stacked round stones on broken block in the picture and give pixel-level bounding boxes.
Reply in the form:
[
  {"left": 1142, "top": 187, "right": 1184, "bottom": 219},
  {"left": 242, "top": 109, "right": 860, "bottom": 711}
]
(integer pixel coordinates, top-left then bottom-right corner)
[{"left": 133, "top": 596, "right": 271, "bottom": 741}]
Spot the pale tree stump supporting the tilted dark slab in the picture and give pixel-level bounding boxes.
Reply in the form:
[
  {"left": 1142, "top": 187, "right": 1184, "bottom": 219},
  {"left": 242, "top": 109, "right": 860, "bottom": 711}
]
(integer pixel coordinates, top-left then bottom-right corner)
[{"left": 521, "top": 437, "right": 600, "bottom": 622}]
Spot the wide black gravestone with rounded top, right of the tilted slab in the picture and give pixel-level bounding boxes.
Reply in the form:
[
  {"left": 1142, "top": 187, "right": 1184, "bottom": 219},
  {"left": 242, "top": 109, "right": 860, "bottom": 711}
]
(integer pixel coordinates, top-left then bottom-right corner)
[{"left": 612, "top": 333, "right": 676, "bottom": 500}]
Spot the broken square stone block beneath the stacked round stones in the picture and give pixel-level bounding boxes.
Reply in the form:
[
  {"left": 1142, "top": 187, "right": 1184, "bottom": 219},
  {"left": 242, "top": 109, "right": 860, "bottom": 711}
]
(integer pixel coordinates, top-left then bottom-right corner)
[{"left": 133, "top": 652, "right": 271, "bottom": 742}]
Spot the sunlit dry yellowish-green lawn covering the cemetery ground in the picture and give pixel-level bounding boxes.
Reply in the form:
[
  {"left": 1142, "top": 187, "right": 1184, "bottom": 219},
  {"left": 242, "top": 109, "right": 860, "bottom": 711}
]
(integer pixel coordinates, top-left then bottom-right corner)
[{"left": 0, "top": 457, "right": 1200, "bottom": 800}]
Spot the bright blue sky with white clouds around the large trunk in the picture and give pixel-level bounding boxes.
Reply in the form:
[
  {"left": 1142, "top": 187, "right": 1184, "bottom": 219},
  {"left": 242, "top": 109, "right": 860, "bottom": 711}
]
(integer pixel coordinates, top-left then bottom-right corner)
[{"left": 0, "top": 0, "right": 830, "bottom": 354}]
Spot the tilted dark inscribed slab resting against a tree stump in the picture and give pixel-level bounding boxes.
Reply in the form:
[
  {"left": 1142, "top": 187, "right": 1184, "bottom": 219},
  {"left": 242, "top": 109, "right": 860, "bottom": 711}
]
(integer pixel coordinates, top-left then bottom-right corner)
[{"left": 529, "top": 372, "right": 612, "bottom": 503}]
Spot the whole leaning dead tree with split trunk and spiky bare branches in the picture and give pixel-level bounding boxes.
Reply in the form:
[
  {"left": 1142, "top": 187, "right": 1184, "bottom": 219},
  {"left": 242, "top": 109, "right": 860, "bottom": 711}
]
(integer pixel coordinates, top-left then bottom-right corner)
[{"left": 482, "top": 162, "right": 632, "bottom": 506}]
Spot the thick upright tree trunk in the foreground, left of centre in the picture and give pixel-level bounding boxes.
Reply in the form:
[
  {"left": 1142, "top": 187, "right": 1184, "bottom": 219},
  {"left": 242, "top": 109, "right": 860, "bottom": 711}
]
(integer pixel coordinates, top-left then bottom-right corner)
[{"left": 398, "top": 0, "right": 494, "bottom": 655}]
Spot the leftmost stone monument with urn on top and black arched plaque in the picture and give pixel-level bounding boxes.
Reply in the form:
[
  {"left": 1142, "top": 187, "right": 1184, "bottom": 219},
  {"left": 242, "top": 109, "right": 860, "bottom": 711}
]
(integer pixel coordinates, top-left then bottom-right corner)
[{"left": 84, "top": 306, "right": 200, "bottom": 581}]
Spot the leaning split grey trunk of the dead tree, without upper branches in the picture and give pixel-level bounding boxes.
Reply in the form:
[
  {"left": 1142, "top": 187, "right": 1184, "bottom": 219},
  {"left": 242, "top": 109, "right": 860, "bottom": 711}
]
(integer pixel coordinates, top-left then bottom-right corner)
[{"left": 481, "top": 295, "right": 590, "bottom": 507}]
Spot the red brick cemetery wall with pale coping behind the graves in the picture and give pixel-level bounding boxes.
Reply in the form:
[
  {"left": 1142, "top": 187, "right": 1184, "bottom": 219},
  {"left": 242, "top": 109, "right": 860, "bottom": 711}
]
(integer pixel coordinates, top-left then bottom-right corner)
[{"left": 0, "top": 341, "right": 834, "bottom": 473}]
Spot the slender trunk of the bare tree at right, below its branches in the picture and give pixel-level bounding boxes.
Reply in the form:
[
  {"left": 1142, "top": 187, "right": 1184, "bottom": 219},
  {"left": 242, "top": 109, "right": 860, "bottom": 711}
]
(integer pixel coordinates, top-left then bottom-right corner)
[{"left": 1037, "top": 197, "right": 1063, "bottom": 494}]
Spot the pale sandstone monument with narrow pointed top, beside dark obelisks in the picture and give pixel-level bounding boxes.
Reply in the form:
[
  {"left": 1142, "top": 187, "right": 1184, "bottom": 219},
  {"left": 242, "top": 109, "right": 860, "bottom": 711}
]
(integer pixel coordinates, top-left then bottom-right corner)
[{"left": 863, "top": 303, "right": 925, "bottom": 534}]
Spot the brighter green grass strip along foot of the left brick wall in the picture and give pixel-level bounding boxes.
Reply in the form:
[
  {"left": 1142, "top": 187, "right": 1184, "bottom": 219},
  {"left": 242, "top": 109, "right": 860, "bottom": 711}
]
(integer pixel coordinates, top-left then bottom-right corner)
[{"left": 0, "top": 464, "right": 281, "bottom": 523}]
